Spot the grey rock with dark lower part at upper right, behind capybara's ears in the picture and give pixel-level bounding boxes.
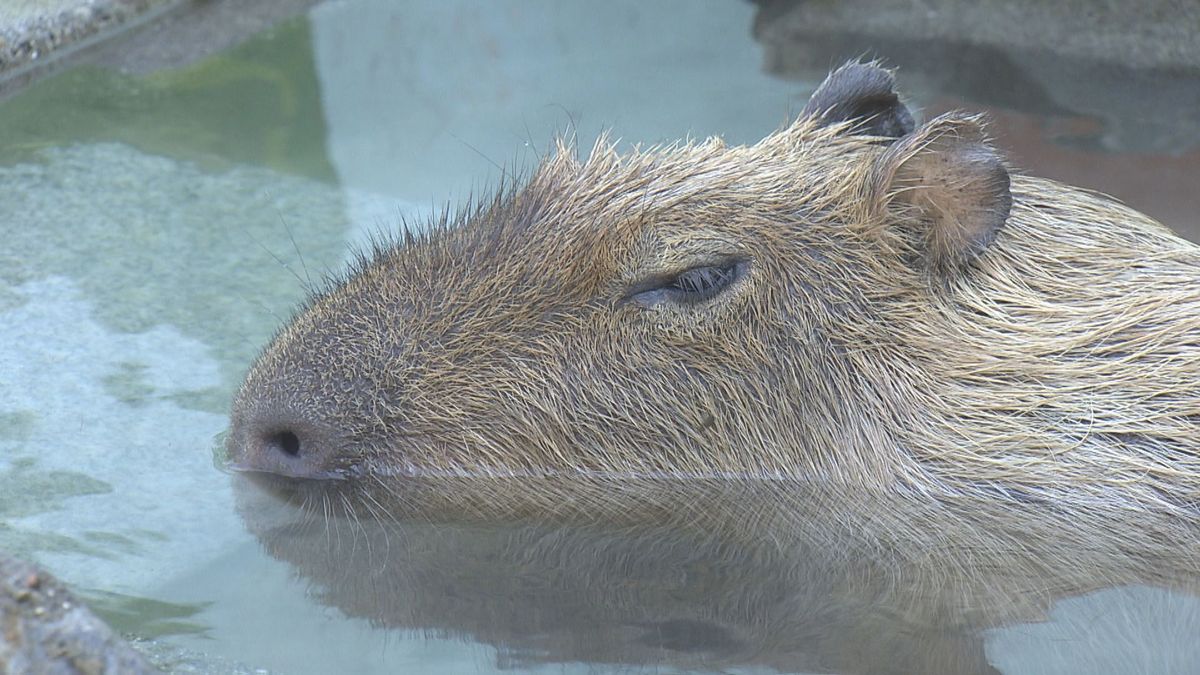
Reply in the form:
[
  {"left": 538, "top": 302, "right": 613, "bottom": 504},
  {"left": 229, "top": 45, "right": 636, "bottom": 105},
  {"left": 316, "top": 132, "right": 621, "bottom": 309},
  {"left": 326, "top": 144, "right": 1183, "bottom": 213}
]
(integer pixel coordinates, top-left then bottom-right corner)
[{"left": 755, "top": 0, "right": 1200, "bottom": 154}]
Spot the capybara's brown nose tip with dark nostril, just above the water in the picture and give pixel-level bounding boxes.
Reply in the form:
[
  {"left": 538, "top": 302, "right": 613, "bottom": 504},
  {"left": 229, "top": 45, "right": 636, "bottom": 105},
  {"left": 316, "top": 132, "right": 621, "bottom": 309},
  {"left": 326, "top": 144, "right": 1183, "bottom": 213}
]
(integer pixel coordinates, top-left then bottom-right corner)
[{"left": 226, "top": 413, "right": 343, "bottom": 479}]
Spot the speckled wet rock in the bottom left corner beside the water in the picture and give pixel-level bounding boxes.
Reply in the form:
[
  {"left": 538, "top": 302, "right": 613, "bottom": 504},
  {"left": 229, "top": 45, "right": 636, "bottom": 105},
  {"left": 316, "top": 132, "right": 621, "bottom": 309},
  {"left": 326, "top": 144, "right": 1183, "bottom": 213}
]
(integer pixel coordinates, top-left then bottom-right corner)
[{"left": 0, "top": 556, "right": 157, "bottom": 675}]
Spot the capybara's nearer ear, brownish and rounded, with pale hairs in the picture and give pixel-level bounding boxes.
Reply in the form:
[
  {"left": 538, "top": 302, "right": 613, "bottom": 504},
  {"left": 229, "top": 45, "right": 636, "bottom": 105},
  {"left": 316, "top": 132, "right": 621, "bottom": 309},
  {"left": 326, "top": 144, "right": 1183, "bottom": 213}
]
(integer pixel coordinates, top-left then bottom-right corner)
[{"left": 870, "top": 113, "right": 1013, "bottom": 270}]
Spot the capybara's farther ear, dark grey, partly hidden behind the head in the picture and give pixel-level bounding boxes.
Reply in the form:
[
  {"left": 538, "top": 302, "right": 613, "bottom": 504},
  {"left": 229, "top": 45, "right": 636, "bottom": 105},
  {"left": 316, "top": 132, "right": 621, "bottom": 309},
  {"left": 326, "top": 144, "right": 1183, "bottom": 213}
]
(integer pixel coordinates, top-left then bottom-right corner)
[{"left": 800, "top": 61, "right": 913, "bottom": 138}]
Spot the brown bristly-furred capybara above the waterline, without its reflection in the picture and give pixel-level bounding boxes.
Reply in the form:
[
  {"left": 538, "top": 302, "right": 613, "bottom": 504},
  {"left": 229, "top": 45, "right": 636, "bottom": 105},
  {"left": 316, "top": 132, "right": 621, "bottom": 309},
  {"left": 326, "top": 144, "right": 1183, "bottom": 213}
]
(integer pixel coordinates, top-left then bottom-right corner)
[{"left": 229, "top": 64, "right": 1200, "bottom": 514}]
